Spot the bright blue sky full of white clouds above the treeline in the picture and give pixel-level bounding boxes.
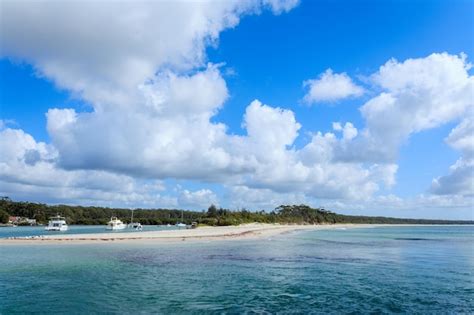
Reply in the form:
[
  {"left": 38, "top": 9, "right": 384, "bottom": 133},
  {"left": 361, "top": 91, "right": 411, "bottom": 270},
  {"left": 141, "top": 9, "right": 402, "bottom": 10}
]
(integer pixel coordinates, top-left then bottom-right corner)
[{"left": 0, "top": 0, "right": 474, "bottom": 220}]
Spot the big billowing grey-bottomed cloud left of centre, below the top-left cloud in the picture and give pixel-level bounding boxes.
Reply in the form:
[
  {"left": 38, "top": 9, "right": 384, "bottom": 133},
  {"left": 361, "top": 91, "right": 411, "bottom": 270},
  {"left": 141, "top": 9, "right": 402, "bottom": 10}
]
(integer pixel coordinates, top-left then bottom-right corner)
[{"left": 47, "top": 66, "right": 243, "bottom": 178}]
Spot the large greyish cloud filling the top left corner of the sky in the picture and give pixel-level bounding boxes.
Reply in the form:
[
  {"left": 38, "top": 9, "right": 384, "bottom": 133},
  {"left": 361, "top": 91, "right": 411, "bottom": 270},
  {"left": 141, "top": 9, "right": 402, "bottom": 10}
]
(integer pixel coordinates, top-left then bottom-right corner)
[{"left": 0, "top": 0, "right": 298, "bottom": 110}]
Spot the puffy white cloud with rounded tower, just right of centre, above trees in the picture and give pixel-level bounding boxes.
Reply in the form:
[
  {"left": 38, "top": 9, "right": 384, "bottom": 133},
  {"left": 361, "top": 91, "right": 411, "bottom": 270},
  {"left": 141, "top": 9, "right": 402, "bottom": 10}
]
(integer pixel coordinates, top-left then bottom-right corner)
[{"left": 230, "top": 101, "right": 396, "bottom": 199}]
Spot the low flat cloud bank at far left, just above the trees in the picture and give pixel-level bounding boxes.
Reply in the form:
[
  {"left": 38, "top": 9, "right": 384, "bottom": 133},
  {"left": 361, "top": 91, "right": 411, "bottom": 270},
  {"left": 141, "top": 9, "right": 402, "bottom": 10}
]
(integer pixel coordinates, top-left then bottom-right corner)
[{"left": 0, "top": 128, "right": 177, "bottom": 207}]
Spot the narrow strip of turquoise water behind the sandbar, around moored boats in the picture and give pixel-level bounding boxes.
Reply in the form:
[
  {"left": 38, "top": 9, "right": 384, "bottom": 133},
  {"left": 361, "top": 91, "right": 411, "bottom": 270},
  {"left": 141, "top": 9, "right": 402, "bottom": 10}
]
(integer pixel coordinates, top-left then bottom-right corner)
[{"left": 0, "top": 225, "right": 181, "bottom": 238}]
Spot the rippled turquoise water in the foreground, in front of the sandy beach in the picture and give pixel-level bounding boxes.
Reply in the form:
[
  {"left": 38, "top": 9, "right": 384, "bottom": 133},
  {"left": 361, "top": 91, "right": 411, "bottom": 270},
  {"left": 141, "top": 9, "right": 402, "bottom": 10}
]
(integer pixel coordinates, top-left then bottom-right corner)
[{"left": 0, "top": 226, "right": 474, "bottom": 314}]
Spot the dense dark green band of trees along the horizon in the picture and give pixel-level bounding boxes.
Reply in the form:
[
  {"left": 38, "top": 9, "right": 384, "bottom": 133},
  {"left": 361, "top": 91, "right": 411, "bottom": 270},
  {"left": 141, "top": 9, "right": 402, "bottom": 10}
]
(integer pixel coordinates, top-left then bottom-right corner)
[{"left": 0, "top": 197, "right": 474, "bottom": 226}]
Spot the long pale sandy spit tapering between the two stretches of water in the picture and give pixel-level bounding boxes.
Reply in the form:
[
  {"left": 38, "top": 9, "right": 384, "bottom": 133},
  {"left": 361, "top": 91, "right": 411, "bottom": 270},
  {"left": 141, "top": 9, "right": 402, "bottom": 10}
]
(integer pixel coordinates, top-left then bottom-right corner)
[{"left": 0, "top": 223, "right": 468, "bottom": 245}]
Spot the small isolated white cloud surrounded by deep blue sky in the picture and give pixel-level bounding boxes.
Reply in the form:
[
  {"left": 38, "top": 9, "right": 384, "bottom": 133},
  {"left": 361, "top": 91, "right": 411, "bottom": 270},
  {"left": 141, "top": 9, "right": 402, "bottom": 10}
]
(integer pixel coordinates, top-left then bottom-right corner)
[{"left": 303, "top": 69, "right": 364, "bottom": 104}]
